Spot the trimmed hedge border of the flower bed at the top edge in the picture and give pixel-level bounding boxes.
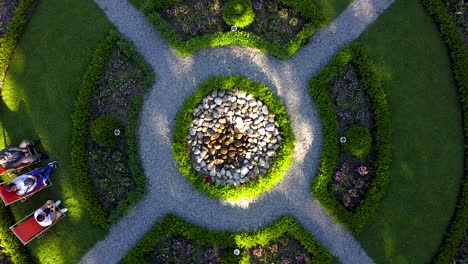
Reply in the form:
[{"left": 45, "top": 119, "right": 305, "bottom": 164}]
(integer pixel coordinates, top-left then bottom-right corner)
[{"left": 130, "top": 0, "right": 327, "bottom": 59}]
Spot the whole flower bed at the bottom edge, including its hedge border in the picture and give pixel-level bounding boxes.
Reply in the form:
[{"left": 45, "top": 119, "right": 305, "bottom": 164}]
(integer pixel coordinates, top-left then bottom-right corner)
[{"left": 122, "top": 215, "right": 333, "bottom": 264}]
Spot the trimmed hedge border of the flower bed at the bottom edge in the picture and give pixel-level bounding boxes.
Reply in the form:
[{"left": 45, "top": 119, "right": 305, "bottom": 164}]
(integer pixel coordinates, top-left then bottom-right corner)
[{"left": 122, "top": 214, "right": 334, "bottom": 264}]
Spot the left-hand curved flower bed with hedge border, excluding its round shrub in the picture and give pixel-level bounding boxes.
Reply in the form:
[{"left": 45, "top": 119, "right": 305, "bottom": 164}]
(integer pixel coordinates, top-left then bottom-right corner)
[{"left": 72, "top": 31, "right": 154, "bottom": 226}]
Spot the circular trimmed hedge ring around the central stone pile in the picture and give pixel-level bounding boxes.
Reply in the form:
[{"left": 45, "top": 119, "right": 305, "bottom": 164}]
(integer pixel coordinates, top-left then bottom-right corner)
[{"left": 172, "top": 75, "right": 295, "bottom": 200}]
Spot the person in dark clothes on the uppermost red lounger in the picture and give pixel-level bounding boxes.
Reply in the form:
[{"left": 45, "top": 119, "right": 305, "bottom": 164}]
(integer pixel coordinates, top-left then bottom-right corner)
[{"left": 0, "top": 140, "right": 41, "bottom": 171}]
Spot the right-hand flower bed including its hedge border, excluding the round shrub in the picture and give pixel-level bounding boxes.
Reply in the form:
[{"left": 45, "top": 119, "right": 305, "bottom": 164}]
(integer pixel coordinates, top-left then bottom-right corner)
[{"left": 309, "top": 45, "right": 391, "bottom": 233}]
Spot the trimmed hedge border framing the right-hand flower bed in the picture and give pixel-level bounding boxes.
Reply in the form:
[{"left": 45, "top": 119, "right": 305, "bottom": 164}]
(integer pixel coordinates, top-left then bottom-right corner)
[{"left": 309, "top": 44, "right": 391, "bottom": 234}]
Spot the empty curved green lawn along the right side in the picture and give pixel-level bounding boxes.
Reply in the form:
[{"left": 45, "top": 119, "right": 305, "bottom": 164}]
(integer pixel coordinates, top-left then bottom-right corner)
[{"left": 358, "top": 0, "right": 463, "bottom": 264}]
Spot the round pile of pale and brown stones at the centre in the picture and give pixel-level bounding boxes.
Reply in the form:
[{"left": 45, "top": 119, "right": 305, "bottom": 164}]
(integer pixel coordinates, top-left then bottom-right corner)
[{"left": 187, "top": 89, "right": 282, "bottom": 186}]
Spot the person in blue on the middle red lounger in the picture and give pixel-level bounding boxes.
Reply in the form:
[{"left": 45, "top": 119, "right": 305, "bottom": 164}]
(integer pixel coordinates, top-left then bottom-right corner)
[{"left": 6, "top": 161, "right": 57, "bottom": 196}]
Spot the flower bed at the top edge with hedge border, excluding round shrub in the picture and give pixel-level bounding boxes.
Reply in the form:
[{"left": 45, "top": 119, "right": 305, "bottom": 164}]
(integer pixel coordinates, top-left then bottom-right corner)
[{"left": 131, "top": 0, "right": 325, "bottom": 59}]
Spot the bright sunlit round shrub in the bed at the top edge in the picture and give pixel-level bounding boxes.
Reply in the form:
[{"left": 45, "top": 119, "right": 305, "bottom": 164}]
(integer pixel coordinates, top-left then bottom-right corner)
[{"left": 223, "top": 0, "right": 255, "bottom": 28}]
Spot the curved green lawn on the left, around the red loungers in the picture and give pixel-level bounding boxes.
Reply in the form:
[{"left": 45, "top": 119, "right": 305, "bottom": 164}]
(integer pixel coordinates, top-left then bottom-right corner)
[{"left": 0, "top": 0, "right": 111, "bottom": 263}]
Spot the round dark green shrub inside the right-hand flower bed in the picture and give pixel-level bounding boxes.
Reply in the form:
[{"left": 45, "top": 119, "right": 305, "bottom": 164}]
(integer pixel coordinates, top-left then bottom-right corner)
[{"left": 343, "top": 126, "right": 372, "bottom": 158}]
